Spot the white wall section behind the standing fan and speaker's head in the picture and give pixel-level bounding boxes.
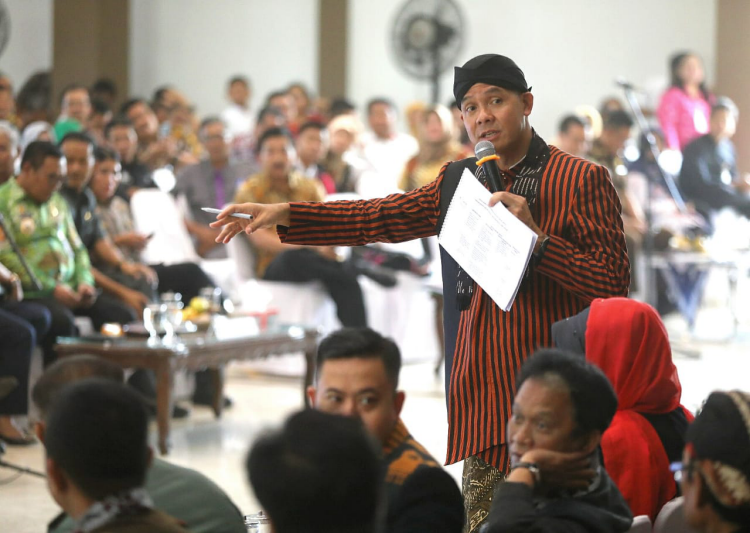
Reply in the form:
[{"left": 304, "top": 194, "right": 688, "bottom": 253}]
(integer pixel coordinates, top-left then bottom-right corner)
[{"left": 348, "top": 0, "right": 716, "bottom": 140}]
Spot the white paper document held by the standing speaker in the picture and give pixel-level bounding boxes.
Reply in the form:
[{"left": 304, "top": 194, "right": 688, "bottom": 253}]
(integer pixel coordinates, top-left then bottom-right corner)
[{"left": 438, "top": 169, "right": 537, "bottom": 311}]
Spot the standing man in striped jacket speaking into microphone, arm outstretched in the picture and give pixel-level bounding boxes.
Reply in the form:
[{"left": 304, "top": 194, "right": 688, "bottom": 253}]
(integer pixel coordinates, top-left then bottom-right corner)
[{"left": 211, "top": 54, "right": 630, "bottom": 532}]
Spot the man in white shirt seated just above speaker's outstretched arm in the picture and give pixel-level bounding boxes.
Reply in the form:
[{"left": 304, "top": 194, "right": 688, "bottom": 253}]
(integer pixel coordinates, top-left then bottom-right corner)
[{"left": 361, "top": 98, "right": 419, "bottom": 196}]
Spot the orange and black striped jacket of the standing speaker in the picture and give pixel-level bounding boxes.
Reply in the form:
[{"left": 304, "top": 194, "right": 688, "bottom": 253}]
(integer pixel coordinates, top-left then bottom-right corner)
[{"left": 278, "top": 146, "right": 630, "bottom": 471}]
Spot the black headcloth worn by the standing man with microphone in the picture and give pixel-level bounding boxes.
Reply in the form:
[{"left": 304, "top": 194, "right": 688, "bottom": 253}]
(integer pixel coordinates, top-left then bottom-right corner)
[{"left": 453, "top": 54, "right": 531, "bottom": 108}]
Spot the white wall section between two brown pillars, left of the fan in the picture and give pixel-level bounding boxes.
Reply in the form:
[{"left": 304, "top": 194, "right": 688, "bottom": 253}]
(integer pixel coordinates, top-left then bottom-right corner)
[{"left": 130, "top": 0, "right": 318, "bottom": 116}]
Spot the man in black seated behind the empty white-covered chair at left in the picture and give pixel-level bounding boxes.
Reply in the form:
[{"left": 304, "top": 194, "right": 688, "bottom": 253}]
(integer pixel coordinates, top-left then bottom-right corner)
[{"left": 104, "top": 116, "right": 156, "bottom": 202}]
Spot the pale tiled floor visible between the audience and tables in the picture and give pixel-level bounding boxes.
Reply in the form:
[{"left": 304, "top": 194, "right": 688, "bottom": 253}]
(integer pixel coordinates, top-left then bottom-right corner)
[{"left": 0, "top": 290, "right": 750, "bottom": 533}]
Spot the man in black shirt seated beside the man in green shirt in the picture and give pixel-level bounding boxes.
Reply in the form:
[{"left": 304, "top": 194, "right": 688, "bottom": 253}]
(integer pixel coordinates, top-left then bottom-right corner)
[{"left": 60, "top": 132, "right": 158, "bottom": 316}]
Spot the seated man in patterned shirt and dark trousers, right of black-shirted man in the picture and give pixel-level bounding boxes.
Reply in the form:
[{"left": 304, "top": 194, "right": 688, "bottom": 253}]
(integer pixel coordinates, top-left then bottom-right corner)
[{"left": 89, "top": 147, "right": 219, "bottom": 310}]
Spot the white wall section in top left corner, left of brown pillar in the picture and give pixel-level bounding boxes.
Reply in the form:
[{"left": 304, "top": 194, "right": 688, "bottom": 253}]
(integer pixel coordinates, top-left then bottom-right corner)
[{"left": 0, "top": 0, "right": 52, "bottom": 90}]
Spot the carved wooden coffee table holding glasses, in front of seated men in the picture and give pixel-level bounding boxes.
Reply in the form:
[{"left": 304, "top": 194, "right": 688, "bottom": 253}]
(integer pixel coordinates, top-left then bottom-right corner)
[{"left": 55, "top": 324, "right": 320, "bottom": 454}]
